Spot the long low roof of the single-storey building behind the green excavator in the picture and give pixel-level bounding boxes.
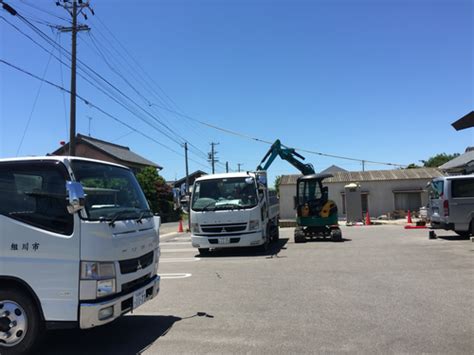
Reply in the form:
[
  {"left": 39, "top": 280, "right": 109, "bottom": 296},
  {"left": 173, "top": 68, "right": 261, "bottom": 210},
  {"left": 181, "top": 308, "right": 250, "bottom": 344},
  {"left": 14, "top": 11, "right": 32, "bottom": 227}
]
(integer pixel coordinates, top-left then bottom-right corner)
[{"left": 280, "top": 168, "right": 444, "bottom": 185}]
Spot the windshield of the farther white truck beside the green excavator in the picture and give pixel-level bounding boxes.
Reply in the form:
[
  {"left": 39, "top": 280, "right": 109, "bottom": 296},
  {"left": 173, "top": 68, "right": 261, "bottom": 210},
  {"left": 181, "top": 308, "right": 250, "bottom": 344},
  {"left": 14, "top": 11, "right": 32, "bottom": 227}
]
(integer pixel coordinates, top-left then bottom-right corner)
[{"left": 191, "top": 177, "right": 257, "bottom": 211}]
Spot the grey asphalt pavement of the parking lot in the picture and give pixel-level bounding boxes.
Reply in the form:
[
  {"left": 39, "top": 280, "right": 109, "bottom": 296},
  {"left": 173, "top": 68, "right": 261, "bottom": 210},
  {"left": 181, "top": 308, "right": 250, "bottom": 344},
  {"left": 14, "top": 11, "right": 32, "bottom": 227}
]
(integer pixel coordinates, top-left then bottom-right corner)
[{"left": 40, "top": 226, "right": 474, "bottom": 354}]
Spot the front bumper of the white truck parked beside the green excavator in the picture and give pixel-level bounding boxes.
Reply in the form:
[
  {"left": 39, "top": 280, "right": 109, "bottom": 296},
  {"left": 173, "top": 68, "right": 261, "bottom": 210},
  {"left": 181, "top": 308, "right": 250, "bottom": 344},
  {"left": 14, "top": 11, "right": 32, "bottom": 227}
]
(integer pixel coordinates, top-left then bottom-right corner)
[{"left": 191, "top": 230, "right": 265, "bottom": 248}]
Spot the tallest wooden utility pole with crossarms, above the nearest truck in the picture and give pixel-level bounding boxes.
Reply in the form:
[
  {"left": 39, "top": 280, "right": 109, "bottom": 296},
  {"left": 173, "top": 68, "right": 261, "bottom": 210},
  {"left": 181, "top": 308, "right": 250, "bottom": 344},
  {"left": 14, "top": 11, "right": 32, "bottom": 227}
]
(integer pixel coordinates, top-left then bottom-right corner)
[{"left": 56, "top": 0, "right": 94, "bottom": 155}]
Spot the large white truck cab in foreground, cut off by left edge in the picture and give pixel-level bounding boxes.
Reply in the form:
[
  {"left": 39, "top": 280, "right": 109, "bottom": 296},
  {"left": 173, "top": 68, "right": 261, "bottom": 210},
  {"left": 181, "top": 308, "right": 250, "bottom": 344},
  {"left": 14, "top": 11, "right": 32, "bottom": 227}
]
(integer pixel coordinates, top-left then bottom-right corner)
[{"left": 0, "top": 156, "right": 160, "bottom": 354}]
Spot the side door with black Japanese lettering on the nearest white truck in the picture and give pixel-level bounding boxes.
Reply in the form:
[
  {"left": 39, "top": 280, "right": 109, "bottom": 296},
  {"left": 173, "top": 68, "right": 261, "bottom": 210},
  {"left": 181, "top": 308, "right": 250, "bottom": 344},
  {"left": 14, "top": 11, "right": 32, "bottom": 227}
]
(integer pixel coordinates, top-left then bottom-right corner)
[{"left": 0, "top": 160, "right": 79, "bottom": 321}]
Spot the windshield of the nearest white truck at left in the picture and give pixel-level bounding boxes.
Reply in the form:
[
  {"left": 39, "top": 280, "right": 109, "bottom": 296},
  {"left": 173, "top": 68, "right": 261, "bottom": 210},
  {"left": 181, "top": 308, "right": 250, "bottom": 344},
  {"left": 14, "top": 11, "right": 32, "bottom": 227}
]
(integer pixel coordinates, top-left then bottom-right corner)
[{"left": 71, "top": 160, "right": 152, "bottom": 220}]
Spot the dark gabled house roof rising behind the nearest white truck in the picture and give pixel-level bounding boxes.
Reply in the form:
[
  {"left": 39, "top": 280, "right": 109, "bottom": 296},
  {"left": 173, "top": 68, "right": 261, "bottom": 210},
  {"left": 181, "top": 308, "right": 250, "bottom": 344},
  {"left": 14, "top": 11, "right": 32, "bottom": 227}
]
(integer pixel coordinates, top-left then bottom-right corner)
[{"left": 51, "top": 134, "right": 163, "bottom": 173}]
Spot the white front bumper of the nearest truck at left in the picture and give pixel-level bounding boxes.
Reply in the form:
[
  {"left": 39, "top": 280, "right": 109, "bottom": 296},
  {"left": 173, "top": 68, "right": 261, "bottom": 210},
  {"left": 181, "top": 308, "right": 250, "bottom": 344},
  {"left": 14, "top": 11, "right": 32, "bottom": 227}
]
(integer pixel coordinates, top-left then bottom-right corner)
[{"left": 79, "top": 275, "right": 160, "bottom": 329}]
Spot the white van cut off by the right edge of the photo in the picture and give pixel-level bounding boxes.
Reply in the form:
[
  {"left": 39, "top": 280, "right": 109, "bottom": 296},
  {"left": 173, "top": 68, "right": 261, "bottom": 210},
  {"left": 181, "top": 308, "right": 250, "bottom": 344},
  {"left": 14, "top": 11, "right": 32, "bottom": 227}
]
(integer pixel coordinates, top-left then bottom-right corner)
[{"left": 430, "top": 175, "right": 474, "bottom": 237}]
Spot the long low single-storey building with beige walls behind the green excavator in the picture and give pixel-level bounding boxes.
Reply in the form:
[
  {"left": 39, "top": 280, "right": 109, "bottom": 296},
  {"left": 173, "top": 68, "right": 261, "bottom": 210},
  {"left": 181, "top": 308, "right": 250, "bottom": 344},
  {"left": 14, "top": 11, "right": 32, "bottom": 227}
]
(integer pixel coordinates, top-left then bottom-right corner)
[{"left": 280, "top": 168, "right": 444, "bottom": 219}]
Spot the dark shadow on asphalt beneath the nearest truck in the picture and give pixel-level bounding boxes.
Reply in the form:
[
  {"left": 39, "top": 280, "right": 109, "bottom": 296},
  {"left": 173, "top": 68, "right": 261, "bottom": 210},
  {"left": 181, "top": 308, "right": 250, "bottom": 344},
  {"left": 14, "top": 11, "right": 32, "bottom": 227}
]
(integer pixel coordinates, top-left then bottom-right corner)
[{"left": 35, "top": 312, "right": 214, "bottom": 355}]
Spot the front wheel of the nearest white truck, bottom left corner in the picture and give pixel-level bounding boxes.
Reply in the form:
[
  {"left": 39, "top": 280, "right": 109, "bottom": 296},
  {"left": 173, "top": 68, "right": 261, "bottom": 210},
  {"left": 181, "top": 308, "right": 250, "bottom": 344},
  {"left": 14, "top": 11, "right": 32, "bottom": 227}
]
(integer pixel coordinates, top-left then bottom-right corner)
[{"left": 0, "top": 289, "right": 41, "bottom": 355}]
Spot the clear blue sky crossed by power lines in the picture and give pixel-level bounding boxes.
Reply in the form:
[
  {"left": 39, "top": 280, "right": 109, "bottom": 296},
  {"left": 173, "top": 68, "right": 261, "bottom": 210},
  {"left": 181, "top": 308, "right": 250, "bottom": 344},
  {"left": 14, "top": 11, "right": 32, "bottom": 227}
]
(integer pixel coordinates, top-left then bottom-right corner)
[{"left": 0, "top": 0, "right": 474, "bottom": 184}]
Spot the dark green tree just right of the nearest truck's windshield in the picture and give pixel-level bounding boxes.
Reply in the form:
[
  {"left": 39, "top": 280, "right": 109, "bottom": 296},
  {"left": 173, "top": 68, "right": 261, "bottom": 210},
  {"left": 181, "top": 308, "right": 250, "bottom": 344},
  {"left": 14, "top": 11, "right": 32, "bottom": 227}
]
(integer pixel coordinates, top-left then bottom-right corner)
[{"left": 136, "top": 166, "right": 179, "bottom": 222}]
